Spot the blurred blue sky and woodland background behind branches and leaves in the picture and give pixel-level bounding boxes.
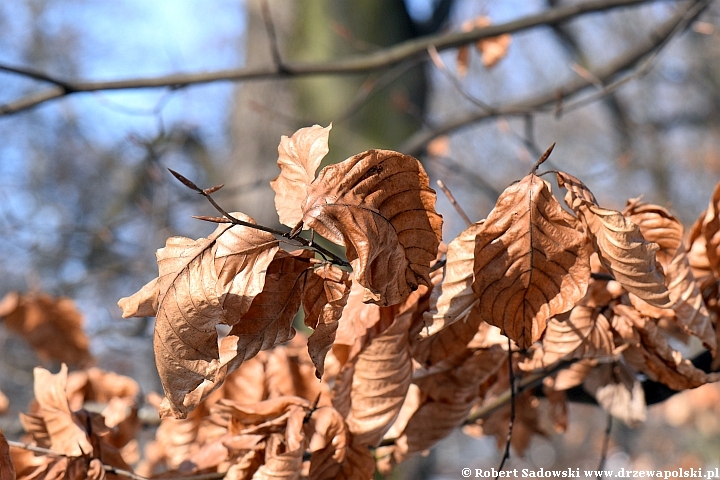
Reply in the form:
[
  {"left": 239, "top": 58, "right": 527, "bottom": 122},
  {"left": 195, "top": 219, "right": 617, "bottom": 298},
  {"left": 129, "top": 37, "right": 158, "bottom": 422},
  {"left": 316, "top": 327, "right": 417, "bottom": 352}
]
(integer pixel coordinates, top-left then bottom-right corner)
[{"left": 0, "top": 0, "right": 720, "bottom": 478}]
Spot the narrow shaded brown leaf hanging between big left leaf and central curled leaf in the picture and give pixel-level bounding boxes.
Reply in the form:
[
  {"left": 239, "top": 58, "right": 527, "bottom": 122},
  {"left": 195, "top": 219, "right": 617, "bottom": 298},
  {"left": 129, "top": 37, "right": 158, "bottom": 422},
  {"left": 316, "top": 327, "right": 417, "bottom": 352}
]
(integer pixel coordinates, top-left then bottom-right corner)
[{"left": 303, "top": 264, "right": 350, "bottom": 378}]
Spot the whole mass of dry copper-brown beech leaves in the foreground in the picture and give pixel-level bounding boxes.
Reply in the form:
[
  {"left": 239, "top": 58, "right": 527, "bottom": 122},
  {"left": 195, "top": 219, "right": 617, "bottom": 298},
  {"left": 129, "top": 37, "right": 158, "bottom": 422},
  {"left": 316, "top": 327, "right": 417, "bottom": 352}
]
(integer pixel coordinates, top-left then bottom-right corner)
[{"left": 0, "top": 125, "right": 720, "bottom": 480}]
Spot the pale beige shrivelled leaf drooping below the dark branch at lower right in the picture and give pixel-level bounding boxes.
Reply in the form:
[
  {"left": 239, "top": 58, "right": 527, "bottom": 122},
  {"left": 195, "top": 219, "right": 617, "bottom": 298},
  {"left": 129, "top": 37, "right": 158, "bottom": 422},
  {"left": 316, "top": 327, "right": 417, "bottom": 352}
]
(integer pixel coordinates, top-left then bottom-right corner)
[{"left": 583, "top": 363, "right": 647, "bottom": 427}]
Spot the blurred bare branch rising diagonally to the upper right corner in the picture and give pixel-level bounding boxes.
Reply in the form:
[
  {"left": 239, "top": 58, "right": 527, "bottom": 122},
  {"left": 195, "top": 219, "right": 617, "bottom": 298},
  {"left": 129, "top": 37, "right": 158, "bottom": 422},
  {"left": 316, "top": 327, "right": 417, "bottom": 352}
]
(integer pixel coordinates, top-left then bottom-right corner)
[{"left": 399, "top": 0, "right": 711, "bottom": 156}]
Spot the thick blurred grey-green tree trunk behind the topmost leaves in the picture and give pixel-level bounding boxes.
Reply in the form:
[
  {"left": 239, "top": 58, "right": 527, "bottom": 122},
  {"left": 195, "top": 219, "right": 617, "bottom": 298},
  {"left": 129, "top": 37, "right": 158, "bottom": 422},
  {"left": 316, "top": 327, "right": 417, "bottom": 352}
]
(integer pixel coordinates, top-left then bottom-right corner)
[{"left": 228, "top": 0, "right": 452, "bottom": 225}]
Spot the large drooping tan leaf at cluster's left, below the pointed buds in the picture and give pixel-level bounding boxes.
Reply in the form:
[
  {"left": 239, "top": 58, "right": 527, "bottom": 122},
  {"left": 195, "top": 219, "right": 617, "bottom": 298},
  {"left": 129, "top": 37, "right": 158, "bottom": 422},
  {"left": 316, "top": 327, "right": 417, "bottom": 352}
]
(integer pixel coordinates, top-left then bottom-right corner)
[{"left": 118, "top": 212, "right": 278, "bottom": 417}]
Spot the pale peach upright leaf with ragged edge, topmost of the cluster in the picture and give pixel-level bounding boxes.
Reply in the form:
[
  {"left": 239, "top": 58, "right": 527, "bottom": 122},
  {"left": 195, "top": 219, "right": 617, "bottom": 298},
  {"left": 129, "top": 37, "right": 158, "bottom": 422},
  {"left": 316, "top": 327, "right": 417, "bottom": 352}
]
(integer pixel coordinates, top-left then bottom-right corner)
[{"left": 270, "top": 125, "right": 332, "bottom": 228}]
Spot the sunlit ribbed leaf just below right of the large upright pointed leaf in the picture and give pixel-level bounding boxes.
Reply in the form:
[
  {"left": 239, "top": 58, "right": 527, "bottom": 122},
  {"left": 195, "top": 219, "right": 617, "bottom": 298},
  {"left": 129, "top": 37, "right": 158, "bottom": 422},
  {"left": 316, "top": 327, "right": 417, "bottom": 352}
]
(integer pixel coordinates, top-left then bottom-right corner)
[{"left": 533, "top": 305, "right": 615, "bottom": 369}]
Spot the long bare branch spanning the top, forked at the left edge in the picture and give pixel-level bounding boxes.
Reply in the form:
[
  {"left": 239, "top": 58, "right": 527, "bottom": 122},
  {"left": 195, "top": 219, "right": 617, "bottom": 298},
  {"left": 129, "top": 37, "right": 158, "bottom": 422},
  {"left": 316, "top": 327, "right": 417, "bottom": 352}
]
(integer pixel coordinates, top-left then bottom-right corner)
[{"left": 0, "top": 0, "right": 680, "bottom": 116}]
